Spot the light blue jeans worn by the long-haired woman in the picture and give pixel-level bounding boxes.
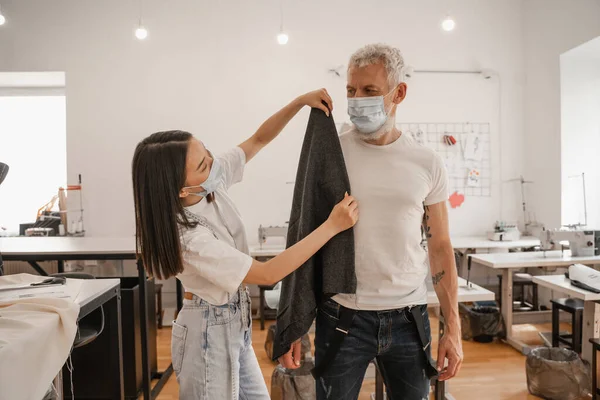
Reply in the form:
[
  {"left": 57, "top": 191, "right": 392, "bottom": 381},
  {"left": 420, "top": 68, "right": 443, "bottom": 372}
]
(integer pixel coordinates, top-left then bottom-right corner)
[{"left": 171, "top": 289, "right": 269, "bottom": 400}]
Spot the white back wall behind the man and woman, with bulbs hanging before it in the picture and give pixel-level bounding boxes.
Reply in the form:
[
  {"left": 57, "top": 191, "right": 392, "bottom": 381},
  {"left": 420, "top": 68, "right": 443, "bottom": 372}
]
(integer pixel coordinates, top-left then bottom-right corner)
[{"left": 0, "top": 0, "right": 524, "bottom": 242}]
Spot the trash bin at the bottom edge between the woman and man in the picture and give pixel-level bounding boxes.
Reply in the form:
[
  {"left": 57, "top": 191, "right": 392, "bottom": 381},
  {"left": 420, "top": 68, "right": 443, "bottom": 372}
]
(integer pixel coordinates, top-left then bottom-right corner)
[{"left": 271, "top": 358, "right": 317, "bottom": 400}]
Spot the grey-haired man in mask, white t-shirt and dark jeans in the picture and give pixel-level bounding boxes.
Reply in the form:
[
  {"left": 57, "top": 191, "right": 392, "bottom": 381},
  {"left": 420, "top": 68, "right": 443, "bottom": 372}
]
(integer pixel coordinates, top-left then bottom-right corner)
[{"left": 280, "top": 44, "right": 463, "bottom": 400}]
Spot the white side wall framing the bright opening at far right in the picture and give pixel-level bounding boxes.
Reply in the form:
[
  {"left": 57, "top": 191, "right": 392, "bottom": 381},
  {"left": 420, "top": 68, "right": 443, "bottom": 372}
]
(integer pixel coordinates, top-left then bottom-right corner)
[{"left": 523, "top": 0, "right": 600, "bottom": 228}]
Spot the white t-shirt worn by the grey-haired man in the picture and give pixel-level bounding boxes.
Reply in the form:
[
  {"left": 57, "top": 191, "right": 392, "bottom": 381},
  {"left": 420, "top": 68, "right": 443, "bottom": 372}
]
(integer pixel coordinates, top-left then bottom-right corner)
[{"left": 333, "top": 132, "right": 448, "bottom": 310}]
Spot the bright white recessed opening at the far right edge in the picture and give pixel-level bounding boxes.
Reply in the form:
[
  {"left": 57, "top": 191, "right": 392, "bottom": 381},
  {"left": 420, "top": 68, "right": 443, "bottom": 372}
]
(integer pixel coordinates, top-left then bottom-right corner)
[{"left": 560, "top": 37, "right": 600, "bottom": 229}]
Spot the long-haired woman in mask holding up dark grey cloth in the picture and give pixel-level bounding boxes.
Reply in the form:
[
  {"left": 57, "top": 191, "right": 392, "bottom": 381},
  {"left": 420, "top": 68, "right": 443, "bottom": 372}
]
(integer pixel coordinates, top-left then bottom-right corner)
[{"left": 132, "top": 89, "right": 358, "bottom": 400}]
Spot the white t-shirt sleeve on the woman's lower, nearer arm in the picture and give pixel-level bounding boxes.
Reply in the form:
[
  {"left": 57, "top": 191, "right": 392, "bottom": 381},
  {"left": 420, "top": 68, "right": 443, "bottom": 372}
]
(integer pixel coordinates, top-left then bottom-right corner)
[{"left": 183, "top": 227, "right": 252, "bottom": 294}]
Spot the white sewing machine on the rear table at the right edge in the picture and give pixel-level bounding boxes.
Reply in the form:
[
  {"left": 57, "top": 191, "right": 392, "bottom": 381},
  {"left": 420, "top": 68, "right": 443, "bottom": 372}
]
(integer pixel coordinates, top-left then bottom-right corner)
[{"left": 539, "top": 229, "right": 600, "bottom": 257}]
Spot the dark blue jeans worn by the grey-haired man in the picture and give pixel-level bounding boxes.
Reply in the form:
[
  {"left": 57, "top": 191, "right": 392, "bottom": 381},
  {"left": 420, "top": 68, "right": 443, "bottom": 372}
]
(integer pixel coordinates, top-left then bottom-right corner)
[{"left": 315, "top": 299, "right": 431, "bottom": 400}]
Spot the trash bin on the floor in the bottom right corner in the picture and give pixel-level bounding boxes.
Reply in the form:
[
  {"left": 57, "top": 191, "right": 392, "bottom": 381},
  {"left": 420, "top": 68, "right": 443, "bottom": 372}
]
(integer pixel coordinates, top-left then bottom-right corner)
[{"left": 525, "top": 347, "right": 591, "bottom": 400}]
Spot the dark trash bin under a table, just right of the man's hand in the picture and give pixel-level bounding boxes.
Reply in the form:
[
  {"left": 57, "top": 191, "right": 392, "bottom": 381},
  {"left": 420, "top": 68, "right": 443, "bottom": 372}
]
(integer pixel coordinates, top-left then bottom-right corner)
[{"left": 459, "top": 304, "right": 506, "bottom": 343}]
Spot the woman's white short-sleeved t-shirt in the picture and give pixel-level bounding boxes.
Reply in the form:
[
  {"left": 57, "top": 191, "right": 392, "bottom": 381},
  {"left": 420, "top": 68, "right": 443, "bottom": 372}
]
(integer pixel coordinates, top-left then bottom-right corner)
[{"left": 177, "top": 147, "right": 252, "bottom": 305}]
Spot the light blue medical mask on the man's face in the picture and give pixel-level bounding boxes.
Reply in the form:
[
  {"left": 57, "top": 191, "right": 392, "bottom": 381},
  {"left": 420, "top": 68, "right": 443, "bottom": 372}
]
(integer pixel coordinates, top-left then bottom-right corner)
[{"left": 348, "top": 87, "right": 397, "bottom": 134}]
